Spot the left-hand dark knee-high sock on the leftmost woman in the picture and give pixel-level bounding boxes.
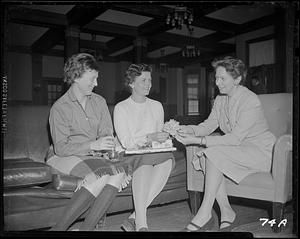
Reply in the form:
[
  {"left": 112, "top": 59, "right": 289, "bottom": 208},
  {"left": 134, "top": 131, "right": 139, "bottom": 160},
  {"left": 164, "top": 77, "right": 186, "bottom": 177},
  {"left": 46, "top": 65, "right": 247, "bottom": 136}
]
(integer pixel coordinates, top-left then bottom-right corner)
[{"left": 50, "top": 187, "right": 95, "bottom": 231}]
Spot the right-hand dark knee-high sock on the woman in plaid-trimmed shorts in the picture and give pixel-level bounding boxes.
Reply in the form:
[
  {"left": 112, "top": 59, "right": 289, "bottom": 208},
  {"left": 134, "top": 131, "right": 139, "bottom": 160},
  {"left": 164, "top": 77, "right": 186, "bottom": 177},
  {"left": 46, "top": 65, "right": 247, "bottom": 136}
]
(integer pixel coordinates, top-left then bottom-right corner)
[{"left": 79, "top": 184, "right": 118, "bottom": 231}]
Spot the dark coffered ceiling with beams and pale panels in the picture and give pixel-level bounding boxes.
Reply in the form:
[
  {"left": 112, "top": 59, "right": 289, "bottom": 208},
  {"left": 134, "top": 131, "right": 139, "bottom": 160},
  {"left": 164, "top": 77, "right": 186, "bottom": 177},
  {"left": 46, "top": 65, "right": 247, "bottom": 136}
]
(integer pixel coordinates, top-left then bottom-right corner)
[{"left": 5, "top": 1, "right": 281, "bottom": 66}]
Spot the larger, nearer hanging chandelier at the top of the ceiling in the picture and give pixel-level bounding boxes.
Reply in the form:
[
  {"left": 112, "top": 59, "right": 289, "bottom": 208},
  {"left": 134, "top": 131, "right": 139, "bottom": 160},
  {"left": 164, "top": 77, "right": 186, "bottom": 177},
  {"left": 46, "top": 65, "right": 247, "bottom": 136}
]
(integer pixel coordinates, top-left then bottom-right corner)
[{"left": 166, "top": 6, "right": 194, "bottom": 30}]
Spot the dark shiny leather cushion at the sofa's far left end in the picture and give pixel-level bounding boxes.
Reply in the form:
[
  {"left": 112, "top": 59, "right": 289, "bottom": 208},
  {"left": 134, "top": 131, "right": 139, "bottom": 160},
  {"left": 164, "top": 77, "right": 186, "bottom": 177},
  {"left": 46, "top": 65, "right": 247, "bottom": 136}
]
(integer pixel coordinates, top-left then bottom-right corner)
[{"left": 3, "top": 158, "right": 52, "bottom": 188}]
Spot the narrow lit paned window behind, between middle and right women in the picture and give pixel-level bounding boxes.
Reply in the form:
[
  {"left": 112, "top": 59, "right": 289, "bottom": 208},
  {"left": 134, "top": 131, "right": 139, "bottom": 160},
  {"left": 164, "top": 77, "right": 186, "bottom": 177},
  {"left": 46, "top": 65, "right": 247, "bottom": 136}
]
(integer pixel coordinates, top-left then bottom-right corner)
[{"left": 187, "top": 74, "right": 199, "bottom": 115}]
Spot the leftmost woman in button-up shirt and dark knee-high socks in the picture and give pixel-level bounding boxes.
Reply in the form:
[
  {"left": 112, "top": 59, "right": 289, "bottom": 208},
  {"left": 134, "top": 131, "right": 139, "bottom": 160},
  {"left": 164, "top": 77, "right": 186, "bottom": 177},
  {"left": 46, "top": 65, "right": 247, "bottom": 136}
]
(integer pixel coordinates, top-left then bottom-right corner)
[{"left": 47, "top": 53, "right": 131, "bottom": 231}]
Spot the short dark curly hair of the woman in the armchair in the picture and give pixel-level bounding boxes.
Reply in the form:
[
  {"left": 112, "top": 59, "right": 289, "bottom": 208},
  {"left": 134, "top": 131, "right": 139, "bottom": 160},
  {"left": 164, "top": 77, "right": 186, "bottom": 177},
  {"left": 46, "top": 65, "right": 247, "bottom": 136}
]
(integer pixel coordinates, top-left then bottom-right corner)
[{"left": 211, "top": 56, "right": 247, "bottom": 85}]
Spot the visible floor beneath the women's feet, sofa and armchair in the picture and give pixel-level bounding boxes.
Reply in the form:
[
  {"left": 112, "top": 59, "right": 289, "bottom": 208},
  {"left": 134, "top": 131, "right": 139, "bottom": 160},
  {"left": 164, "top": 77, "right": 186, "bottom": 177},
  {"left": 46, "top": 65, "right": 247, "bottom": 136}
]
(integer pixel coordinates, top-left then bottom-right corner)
[{"left": 72, "top": 198, "right": 296, "bottom": 238}]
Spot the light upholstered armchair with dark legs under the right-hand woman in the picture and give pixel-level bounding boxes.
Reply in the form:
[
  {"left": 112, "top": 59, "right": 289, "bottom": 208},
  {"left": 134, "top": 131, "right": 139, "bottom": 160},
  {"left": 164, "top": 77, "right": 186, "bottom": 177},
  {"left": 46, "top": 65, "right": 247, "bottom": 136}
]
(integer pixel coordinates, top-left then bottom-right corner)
[{"left": 186, "top": 93, "right": 293, "bottom": 232}]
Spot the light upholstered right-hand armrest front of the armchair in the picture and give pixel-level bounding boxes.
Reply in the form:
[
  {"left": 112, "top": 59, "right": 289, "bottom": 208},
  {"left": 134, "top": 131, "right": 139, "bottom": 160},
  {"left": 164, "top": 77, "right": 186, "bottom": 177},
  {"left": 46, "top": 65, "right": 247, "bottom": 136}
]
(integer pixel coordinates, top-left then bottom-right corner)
[{"left": 272, "top": 134, "right": 293, "bottom": 203}]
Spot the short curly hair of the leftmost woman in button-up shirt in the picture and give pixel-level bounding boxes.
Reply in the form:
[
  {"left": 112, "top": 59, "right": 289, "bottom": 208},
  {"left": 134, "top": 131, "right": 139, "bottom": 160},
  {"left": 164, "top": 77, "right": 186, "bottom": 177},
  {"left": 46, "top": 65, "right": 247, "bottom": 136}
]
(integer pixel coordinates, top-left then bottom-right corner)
[{"left": 63, "top": 53, "right": 99, "bottom": 84}]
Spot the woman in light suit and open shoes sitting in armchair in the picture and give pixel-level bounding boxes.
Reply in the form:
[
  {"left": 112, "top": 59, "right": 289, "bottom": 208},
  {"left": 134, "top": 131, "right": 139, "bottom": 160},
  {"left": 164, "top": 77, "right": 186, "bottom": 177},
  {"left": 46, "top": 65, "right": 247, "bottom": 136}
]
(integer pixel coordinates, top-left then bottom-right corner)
[{"left": 176, "top": 56, "right": 275, "bottom": 231}]
